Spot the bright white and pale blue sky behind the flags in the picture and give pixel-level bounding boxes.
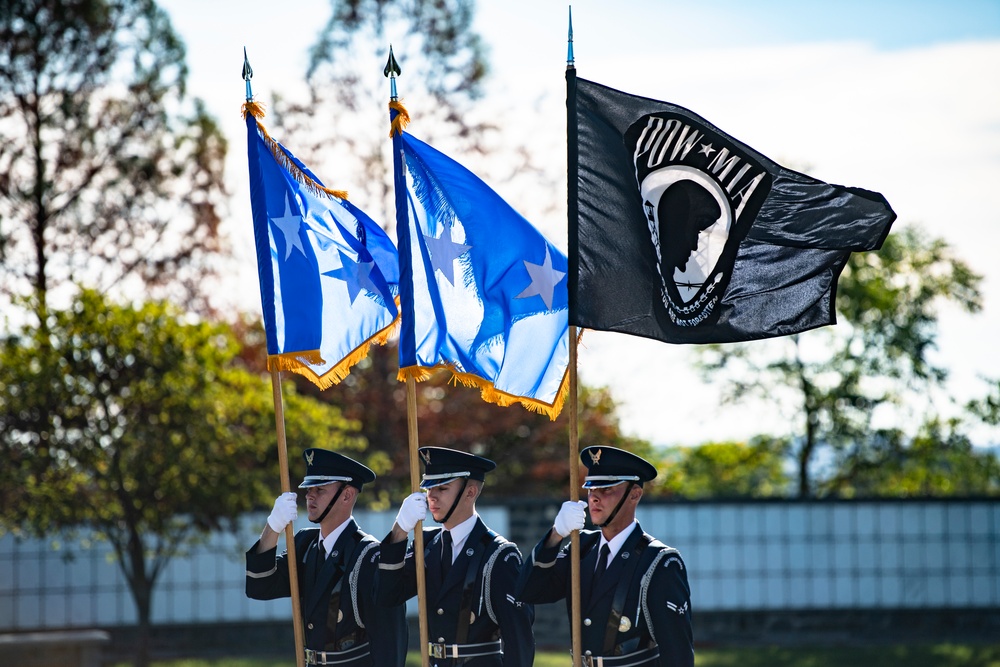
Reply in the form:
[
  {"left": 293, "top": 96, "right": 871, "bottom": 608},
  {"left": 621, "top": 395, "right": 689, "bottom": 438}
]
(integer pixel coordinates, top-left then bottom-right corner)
[{"left": 163, "top": 0, "right": 1000, "bottom": 444}]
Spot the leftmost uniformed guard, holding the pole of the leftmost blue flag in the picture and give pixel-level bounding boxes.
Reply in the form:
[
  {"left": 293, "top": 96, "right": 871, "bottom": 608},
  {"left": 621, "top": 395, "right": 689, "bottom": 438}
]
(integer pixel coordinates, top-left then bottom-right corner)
[{"left": 247, "top": 449, "right": 407, "bottom": 667}]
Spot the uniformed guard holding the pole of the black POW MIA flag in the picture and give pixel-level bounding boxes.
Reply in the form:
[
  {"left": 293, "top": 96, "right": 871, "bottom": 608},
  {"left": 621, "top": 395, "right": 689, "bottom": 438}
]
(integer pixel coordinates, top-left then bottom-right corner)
[{"left": 518, "top": 447, "right": 694, "bottom": 667}]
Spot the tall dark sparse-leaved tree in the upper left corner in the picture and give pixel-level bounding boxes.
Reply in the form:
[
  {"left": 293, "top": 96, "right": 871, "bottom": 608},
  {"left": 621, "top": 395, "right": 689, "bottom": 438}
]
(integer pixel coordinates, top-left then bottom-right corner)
[{"left": 0, "top": 0, "right": 226, "bottom": 322}]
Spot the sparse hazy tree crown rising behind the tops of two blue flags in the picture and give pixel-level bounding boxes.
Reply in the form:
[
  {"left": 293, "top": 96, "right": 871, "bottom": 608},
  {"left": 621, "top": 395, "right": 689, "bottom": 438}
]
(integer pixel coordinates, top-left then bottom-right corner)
[{"left": 261, "top": 0, "right": 562, "bottom": 226}]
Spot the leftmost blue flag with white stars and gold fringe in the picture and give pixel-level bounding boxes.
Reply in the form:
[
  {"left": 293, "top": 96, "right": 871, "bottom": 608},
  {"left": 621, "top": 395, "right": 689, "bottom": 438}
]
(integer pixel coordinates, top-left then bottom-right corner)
[{"left": 244, "top": 102, "right": 399, "bottom": 389}]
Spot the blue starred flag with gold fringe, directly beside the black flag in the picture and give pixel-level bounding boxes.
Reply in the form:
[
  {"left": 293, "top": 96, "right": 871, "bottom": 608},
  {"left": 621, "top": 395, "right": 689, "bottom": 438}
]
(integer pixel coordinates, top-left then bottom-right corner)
[{"left": 393, "top": 104, "right": 569, "bottom": 419}]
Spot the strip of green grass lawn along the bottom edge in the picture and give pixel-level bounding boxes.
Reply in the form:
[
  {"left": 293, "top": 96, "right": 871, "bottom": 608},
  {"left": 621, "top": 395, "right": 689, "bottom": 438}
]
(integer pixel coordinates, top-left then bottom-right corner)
[{"left": 116, "top": 644, "right": 1000, "bottom": 667}]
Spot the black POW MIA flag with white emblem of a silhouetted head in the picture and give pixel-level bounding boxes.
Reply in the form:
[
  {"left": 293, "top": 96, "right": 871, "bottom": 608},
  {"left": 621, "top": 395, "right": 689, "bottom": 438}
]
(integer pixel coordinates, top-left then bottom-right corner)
[{"left": 567, "top": 70, "right": 896, "bottom": 343}]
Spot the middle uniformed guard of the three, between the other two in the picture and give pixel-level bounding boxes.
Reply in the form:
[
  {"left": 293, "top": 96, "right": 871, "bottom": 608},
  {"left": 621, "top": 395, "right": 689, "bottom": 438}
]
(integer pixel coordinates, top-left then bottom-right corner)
[{"left": 378, "top": 447, "right": 535, "bottom": 667}]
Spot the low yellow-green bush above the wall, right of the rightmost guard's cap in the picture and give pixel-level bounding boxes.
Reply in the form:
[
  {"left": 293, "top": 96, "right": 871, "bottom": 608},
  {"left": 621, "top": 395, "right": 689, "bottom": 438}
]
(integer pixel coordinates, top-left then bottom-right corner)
[{"left": 650, "top": 436, "right": 791, "bottom": 498}]
